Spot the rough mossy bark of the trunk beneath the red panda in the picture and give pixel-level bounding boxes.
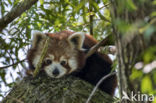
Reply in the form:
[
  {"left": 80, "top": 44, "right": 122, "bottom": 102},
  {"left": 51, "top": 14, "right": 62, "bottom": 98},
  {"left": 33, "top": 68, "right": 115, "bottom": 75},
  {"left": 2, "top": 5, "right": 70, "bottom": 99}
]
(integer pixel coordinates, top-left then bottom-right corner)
[{"left": 2, "top": 74, "right": 115, "bottom": 103}]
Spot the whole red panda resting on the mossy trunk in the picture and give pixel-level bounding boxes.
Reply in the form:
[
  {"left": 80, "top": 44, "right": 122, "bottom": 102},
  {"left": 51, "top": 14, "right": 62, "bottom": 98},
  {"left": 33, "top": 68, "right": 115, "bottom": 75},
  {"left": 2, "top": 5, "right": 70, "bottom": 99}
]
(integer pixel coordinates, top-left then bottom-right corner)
[{"left": 27, "top": 31, "right": 117, "bottom": 95}]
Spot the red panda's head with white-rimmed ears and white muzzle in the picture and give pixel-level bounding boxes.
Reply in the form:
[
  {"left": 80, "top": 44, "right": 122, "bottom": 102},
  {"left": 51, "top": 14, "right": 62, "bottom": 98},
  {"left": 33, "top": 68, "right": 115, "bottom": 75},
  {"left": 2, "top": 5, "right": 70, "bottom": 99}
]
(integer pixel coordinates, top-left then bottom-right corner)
[{"left": 27, "top": 31, "right": 85, "bottom": 78}]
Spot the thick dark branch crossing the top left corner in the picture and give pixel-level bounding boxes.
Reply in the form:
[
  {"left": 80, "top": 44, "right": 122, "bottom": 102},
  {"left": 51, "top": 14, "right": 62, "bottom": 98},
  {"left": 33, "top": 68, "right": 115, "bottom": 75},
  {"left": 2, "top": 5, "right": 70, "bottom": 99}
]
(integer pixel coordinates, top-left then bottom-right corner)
[{"left": 0, "top": 0, "right": 38, "bottom": 32}]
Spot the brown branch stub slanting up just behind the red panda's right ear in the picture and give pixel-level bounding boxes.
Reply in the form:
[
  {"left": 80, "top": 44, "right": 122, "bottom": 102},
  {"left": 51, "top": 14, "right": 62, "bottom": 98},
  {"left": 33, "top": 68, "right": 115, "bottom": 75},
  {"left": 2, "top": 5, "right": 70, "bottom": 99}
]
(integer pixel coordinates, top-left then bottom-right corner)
[{"left": 86, "top": 36, "right": 109, "bottom": 58}]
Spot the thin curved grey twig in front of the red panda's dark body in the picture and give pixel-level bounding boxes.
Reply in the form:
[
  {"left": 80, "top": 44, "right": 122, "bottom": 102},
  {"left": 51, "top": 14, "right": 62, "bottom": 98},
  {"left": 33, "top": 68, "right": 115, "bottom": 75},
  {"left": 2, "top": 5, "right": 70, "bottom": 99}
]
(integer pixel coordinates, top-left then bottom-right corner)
[{"left": 86, "top": 72, "right": 116, "bottom": 103}]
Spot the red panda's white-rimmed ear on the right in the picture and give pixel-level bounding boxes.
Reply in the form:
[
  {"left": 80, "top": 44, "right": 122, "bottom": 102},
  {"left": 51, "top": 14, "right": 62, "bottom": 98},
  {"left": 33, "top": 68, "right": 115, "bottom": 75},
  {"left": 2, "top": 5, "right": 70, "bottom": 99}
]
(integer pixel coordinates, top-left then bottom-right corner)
[{"left": 68, "top": 32, "right": 85, "bottom": 50}]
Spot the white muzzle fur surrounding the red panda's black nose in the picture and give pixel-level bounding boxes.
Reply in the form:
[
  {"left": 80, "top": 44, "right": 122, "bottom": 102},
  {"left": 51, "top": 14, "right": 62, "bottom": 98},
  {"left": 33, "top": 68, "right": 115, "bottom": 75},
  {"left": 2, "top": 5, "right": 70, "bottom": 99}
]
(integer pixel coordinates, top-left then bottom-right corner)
[{"left": 45, "top": 62, "right": 67, "bottom": 78}]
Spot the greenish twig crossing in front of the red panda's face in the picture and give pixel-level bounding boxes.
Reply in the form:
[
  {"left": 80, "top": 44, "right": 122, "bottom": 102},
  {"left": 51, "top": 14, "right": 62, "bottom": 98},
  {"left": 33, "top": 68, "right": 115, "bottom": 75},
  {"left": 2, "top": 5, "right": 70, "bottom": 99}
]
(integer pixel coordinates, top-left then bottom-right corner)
[{"left": 33, "top": 37, "right": 50, "bottom": 77}]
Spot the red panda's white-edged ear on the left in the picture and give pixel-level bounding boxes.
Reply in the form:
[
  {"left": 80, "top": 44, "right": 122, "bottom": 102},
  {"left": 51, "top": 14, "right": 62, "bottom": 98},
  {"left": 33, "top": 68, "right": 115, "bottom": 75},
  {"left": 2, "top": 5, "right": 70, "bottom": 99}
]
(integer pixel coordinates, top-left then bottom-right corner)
[{"left": 31, "top": 30, "right": 46, "bottom": 48}]
